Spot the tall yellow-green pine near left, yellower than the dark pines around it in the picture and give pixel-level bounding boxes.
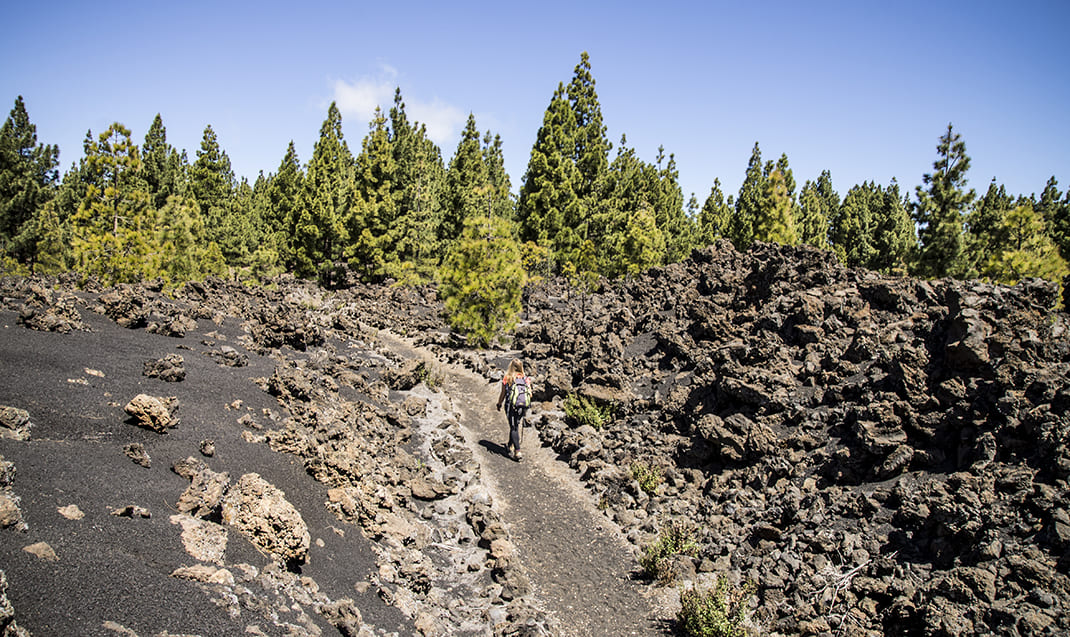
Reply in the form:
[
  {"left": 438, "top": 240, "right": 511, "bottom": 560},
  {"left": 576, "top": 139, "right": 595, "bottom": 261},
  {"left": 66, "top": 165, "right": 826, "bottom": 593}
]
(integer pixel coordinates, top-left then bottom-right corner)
[{"left": 71, "top": 122, "right": 159, "bottom": 284}]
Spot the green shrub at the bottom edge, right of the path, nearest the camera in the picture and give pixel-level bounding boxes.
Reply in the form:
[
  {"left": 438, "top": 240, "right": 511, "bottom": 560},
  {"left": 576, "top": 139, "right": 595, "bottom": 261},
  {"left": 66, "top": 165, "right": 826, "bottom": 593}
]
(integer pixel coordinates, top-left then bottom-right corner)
[{"left": 676, "top": 575, "right": 755, "bottom": 637}]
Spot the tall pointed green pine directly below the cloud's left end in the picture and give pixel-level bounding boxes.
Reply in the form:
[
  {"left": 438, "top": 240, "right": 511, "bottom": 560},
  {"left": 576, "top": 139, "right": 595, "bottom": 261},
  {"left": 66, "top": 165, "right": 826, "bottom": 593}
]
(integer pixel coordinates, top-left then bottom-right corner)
[{"left": 293, "top": 102, "right": 360, "bottom": 286}]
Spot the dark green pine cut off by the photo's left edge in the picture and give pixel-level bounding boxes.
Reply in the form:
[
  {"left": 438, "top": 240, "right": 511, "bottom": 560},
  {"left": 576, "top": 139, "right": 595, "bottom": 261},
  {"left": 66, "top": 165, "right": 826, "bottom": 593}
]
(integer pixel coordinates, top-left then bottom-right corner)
[{"left": 0, "top": 95, "right": 59, "bottom": 268}]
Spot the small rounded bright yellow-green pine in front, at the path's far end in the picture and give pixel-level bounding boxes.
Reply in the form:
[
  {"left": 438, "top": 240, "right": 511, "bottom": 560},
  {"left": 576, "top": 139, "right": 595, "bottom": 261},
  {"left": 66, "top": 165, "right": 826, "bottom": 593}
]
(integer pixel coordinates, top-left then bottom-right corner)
[{"left": 439, "top": 216, "right": 526, "bottom": 345}]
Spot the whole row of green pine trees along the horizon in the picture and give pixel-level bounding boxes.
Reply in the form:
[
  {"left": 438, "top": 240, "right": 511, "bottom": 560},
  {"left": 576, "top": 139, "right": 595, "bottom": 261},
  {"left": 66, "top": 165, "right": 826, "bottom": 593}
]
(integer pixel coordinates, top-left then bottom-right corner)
[{"left": 0, "top": 52, "right": 1070, "bottom": 338}]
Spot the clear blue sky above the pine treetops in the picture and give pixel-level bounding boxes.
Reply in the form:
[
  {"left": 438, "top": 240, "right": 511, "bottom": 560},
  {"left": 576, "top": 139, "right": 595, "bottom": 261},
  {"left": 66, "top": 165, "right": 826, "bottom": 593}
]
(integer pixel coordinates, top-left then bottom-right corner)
[{"left": 0, "top": 0, "right": 1070, "bottom": 203}]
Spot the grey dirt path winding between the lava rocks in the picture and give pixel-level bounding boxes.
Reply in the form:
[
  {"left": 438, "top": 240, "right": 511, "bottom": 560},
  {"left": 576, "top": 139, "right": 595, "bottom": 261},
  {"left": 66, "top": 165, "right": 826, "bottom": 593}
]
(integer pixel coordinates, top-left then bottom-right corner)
[{"left": 380, "top": 333, "right": 668, "bottom": 637}]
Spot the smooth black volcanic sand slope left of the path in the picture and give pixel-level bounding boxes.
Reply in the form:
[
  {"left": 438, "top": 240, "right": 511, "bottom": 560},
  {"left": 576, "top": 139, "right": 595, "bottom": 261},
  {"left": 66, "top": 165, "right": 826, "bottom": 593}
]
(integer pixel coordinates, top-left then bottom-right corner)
[{"left": 0, "top": 307, "right": 413, "bottom": 637}]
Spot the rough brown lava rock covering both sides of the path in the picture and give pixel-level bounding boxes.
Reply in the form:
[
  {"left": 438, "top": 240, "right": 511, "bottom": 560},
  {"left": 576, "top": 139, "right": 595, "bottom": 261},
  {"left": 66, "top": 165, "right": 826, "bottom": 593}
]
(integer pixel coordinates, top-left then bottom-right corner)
[{"left": 0, "top": 236, "right": 1070, "bottom": 635}]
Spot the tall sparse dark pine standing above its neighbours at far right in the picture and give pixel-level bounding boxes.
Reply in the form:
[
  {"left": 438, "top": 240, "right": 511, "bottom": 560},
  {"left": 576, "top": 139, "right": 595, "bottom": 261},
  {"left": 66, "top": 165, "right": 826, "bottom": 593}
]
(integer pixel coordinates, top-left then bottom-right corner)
[{"left": 913, "top": 124, "right": 975, "bottom": 278}]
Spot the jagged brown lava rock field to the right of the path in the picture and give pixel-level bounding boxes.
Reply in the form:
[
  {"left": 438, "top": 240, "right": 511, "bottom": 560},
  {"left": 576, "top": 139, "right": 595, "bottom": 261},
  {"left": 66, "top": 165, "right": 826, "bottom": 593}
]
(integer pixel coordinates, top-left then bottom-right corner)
[{"left": 515, "top": 244, "right": 1070, "bottom": 635}]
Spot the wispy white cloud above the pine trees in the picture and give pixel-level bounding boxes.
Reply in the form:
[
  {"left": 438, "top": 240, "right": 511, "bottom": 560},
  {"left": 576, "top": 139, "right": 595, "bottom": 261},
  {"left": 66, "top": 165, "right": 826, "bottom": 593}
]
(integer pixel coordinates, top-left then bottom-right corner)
[{"left": 333, "top": 64, "right": 468, "bottom": 152}]
